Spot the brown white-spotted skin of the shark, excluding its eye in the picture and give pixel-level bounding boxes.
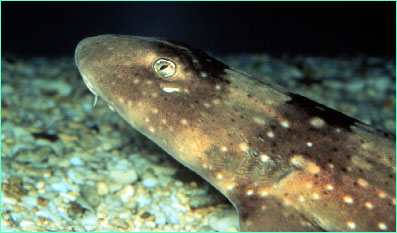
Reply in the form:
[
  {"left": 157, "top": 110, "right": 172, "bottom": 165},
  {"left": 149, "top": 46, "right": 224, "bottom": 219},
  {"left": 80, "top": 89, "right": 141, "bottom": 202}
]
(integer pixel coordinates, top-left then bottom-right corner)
[{"left": 75, "top": 35, "right": 396, "bottom": 231}]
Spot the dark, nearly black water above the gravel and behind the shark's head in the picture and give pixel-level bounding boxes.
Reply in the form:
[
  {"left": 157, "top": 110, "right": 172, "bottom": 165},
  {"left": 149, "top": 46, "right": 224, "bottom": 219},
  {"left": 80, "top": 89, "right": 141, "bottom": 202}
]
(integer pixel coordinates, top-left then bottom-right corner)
[{"left": 1, "top": 2, "right": 396, "bottom": 56}]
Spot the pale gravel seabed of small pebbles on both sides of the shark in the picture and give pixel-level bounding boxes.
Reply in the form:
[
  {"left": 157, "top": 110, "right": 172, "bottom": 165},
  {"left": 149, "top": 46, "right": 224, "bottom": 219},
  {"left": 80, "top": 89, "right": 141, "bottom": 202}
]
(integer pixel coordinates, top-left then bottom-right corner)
[{"left": 1, "top": 54, "right": 396, "bottom": 231}]
